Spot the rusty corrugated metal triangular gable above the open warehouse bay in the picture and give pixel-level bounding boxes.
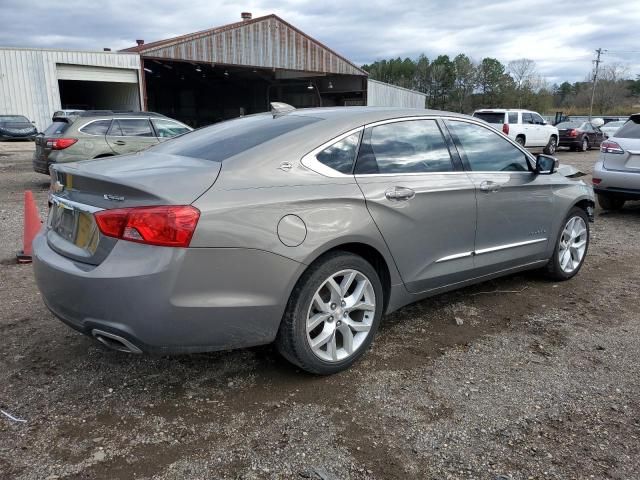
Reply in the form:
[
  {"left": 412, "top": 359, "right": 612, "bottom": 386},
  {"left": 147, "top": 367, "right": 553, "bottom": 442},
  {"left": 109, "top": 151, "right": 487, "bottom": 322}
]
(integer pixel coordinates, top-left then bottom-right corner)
[{"left": 123, "top": 15, "right": 368, "bottom": 76}]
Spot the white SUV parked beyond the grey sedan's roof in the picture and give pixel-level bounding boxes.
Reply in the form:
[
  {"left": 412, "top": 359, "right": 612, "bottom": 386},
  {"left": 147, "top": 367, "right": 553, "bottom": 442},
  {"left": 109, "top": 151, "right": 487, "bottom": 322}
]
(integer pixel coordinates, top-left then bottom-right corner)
[{"left": 473, "top": 108, "right": 558, "bottom": 155}]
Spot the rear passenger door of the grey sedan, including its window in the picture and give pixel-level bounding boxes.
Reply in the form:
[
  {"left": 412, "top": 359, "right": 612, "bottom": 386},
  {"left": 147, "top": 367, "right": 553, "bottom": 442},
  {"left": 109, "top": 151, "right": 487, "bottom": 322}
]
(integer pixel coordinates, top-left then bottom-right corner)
[{"left": 355, "top": 118, "right": 476, "bottom": 293}]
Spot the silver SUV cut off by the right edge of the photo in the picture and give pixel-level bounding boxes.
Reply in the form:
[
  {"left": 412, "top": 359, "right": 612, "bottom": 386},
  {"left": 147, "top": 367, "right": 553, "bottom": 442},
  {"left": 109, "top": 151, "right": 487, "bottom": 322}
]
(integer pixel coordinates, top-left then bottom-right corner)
[{"left": 592, "top": 113, "right": 640, "bottom": 210}]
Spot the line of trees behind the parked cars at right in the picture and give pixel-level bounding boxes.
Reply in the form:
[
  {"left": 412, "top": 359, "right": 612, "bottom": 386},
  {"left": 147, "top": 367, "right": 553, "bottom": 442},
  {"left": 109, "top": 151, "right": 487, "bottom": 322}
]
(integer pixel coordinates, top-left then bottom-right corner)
[{"left": 362, "top": 53, "right": 640, "bottom": 115}]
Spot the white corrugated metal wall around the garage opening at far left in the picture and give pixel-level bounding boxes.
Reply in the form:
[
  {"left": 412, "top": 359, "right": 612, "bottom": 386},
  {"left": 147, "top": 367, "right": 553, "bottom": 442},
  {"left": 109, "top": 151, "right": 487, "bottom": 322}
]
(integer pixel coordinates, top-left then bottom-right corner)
[{"left": 0, "top": 48, "right": 140, "bottom": 130}]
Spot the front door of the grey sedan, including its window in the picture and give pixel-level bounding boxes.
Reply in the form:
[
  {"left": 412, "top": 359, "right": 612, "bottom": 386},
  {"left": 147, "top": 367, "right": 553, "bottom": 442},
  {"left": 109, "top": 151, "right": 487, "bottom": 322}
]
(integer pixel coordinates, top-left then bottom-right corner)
[{"left": 446, "top": 120, "right": 553, "bottom": 276}]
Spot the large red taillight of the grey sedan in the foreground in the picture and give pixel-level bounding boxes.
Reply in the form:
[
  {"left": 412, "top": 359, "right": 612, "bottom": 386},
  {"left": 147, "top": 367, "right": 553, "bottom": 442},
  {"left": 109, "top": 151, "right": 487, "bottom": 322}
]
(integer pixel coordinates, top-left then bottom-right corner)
[{"left": 94, "top": 205, "right": 200, "bottom": 247}]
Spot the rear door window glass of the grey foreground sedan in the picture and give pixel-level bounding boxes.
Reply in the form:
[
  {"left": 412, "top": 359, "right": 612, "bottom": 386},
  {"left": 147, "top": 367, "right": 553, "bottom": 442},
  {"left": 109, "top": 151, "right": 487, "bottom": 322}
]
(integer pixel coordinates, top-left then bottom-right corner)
[{"left": 356, "top": 120, "right": 453, "bottom": 174}]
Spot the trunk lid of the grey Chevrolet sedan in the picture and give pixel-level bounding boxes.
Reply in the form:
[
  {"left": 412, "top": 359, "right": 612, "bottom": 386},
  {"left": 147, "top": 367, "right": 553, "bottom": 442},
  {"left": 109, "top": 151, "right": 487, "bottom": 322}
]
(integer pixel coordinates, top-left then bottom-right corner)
[{"left": 46, "top": 152, "right": 221, "bottom": 265}]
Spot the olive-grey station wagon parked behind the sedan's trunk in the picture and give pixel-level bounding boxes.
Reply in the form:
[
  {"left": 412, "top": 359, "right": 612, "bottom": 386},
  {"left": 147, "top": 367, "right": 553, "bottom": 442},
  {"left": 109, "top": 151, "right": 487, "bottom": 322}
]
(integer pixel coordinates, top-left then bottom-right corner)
[{"left": 33, "top": 110, "right": 192, "bottom": 174}]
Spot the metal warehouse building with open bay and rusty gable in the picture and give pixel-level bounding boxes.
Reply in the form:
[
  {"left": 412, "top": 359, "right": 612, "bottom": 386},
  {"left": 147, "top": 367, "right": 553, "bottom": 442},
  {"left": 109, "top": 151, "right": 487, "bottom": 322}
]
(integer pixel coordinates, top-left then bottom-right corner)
[{"left": 0, "top": 13, "right": 425, "bottom": 129}]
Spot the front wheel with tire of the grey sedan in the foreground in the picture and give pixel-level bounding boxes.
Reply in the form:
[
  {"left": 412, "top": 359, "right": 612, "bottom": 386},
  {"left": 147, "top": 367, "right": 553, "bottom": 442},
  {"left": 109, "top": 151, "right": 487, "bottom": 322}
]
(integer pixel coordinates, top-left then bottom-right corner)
[{"left": 547, "top": 207, "right": 589, "bottom": 281}]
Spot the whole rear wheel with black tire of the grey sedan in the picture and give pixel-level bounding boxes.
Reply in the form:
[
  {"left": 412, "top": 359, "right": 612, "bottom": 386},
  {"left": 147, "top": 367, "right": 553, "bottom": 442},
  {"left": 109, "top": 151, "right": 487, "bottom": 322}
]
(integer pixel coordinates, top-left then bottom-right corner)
[{"left": 276, "top": 251, "right": 384, "bottom": 375}]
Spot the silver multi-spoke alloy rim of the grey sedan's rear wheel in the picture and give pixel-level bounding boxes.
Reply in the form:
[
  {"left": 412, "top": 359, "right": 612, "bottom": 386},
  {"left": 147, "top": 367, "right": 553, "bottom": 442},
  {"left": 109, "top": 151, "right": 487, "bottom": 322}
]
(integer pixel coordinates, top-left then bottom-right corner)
[{"left": 306, "top": 269, "right": 376, "bottom": 362}]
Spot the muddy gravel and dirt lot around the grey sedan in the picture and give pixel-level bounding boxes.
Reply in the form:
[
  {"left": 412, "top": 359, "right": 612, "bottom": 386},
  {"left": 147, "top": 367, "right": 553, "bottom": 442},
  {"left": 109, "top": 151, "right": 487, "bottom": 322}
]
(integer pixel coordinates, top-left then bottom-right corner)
[{"left": 0, "top": 143, "right": 640, "bottom": 480}]
